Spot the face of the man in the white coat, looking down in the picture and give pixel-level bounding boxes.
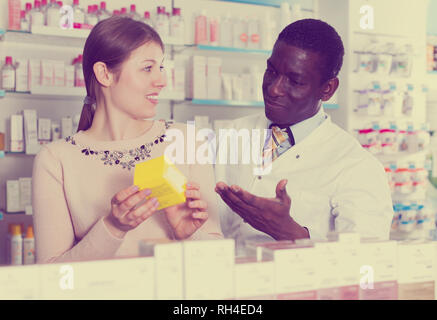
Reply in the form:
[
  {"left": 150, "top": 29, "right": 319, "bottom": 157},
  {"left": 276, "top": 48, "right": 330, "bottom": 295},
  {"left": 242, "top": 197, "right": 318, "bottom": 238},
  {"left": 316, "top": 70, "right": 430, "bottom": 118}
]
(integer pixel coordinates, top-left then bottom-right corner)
[{"left": 263, "top": 41, "right": 326, "bottom": 125}]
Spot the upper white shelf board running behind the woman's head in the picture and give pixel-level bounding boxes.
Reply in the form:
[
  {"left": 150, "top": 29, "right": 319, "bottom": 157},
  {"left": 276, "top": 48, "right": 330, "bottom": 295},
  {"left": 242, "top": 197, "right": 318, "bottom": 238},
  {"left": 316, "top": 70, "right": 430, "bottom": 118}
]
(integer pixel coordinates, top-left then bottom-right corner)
[{"left": 0, "top": 26, "right": 192, "bottom": 47}]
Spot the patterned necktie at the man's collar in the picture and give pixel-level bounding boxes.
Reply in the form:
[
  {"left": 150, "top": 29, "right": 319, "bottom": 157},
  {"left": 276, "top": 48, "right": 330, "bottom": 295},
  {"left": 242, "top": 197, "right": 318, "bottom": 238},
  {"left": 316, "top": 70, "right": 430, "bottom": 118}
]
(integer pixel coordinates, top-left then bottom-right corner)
[{"left": 263, "top": 123, "right": 295, "bottom": 166}]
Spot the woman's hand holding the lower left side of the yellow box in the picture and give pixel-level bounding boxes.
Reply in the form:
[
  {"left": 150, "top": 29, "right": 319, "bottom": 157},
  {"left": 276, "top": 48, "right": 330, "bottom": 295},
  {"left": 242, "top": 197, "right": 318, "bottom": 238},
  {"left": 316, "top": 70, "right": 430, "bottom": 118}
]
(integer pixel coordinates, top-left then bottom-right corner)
[{"left": 104, "top": 186, "right": 159, "bottom": 238}]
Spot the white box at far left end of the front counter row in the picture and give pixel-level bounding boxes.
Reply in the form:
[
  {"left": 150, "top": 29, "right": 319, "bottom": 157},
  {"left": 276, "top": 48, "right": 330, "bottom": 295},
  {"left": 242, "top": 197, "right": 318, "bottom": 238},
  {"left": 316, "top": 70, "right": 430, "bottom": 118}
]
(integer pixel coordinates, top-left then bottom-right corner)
[{"left": 0, "top": 265, "right": 41, "bottom": 300}]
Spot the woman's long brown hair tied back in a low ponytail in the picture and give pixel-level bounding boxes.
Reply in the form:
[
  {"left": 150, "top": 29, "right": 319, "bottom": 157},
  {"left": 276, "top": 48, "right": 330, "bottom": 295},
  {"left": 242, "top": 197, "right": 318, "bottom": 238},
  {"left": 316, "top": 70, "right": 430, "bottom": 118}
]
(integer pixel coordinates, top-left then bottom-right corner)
[{"left": 77, "top": 16, "right": 164, "bottom": 131}]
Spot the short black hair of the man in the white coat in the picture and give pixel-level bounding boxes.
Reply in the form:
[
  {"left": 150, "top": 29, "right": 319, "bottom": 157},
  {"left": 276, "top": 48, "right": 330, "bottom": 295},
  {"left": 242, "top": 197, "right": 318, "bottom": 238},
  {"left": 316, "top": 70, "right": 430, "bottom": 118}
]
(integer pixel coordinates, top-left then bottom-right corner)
[{"left": 277, "top": 19, "right": 344, "bottom": 82}]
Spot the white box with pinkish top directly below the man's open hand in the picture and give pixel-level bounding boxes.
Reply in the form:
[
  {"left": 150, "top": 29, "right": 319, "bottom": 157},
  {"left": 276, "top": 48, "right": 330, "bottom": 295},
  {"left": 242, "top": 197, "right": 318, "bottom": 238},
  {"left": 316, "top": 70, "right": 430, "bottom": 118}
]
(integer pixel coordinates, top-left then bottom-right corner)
[{"left": 263, "top": 243, "right": 319, "bottom": 300}]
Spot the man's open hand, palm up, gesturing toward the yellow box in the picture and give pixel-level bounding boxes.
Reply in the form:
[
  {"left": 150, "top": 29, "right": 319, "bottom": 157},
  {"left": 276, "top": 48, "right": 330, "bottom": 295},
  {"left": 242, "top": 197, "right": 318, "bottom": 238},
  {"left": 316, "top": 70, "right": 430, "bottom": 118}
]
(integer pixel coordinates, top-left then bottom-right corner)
[{"left": 215, "top": 180, "right": 309, "bottom": 240}]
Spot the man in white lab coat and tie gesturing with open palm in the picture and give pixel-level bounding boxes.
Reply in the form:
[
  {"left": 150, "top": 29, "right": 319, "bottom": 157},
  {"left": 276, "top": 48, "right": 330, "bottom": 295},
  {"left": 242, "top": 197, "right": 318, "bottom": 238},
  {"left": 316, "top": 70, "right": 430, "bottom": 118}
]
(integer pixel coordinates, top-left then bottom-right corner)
[{"left": 215, "top": 19, "right": 393, "bottom": 245}]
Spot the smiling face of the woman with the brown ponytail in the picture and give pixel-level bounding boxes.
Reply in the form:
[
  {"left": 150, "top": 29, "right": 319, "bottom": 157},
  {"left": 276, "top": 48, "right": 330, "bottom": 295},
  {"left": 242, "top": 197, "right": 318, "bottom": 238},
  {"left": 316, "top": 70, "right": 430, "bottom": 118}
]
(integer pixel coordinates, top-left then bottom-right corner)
[{"left": 109, "top": 42, "right": 167, "bottom": 120}]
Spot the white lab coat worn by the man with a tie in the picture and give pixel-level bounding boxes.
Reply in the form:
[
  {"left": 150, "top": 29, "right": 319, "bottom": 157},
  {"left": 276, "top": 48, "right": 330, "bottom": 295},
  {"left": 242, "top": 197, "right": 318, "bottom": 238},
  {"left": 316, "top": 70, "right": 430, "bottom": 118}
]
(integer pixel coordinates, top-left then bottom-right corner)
[{"left": 215, "top": 113, "right": 393, "bottom": 245}]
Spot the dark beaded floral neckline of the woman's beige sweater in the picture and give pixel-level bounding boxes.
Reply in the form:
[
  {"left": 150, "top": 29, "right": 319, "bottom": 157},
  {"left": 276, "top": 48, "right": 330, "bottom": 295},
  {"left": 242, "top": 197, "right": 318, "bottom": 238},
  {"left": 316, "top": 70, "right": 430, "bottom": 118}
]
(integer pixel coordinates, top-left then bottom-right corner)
[{"left": 65, "top": 121, "right": 173, "bottom": 170}]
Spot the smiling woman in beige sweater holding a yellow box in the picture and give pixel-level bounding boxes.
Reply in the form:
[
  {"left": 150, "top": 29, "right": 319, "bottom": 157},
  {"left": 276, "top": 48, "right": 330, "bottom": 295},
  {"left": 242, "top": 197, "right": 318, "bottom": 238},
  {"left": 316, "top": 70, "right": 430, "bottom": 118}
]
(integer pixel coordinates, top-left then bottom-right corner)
[{"left": 33, "top": 17, "right": 222, "bottom": 263}]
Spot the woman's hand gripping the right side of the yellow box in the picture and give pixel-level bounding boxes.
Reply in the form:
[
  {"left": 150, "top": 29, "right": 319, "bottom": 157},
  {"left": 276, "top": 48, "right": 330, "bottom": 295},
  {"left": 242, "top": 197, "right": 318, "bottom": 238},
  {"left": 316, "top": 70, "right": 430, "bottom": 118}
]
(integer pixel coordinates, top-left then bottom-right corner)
[{"left": 164, "top": 182, "right": 208, "bottom": 240}]
